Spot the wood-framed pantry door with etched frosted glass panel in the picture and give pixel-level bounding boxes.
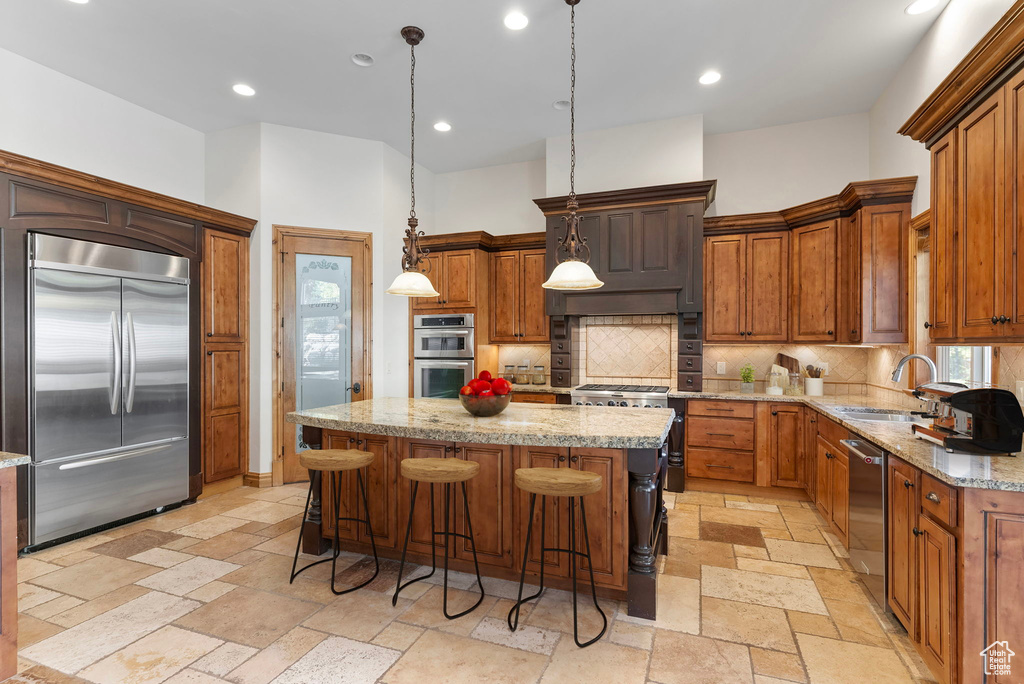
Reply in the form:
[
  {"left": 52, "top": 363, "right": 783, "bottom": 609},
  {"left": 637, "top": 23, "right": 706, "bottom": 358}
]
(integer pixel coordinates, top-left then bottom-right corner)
[{"left": 274, "top": 228, "right": 371, "bottom": 482}]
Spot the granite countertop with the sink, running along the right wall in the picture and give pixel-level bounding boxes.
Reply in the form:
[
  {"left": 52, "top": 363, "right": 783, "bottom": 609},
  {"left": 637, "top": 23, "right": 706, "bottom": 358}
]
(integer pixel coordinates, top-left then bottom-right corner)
[{"left": 670, "top": 392, "right": 1024, "bottom": 491}]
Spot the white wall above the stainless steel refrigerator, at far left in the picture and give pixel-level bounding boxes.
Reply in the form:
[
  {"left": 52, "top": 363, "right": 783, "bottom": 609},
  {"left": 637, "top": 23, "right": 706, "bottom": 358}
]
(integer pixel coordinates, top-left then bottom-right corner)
[{"left": 0, "top": 49, "right": 204, "bottom": 203}]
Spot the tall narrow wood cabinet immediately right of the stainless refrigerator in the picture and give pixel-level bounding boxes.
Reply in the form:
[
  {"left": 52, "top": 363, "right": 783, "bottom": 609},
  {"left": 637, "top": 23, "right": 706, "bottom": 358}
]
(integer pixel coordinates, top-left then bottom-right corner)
[{"left": 201, "top": 228, "right": 249, "bottom": 482}]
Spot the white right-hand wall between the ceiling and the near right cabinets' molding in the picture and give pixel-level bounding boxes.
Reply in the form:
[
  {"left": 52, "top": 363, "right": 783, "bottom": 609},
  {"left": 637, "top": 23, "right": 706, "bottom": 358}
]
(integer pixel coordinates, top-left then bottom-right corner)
[{"left": 870, "top": 0, "right": 1014, "bottom": 214}]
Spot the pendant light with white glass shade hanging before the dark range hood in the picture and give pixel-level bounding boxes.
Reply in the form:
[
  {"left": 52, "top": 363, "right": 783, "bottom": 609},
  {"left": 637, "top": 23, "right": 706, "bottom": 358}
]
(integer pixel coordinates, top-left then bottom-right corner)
[{"left": 542, "top": 0, "right": 604, "bottom": 291}]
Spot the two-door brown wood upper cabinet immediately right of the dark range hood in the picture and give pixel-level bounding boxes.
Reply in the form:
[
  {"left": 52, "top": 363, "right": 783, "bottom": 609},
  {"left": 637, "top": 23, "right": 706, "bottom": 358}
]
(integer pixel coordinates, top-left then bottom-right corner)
[{"left": 705, "top": 232, "right": 790, "bottom": 343}]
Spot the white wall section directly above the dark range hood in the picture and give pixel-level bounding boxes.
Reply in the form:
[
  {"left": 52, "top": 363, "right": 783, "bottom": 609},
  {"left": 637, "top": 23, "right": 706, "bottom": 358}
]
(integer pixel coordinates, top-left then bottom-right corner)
[{"left": 546, "top": 115, "right": 705, "bottom": 197}]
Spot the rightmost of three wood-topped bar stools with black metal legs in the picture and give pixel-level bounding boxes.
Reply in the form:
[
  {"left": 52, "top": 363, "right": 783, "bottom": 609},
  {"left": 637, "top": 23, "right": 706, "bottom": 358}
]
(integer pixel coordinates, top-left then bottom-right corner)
[{"left": 508, "top": 468, "right": 608, "bottom": 648}]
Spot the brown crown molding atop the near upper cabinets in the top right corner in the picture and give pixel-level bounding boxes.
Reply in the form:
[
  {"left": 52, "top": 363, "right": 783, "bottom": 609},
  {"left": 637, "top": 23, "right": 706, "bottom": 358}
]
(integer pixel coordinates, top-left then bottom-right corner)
[{"left": 899, "top": 0, "right": 1024, "bottom": 146}]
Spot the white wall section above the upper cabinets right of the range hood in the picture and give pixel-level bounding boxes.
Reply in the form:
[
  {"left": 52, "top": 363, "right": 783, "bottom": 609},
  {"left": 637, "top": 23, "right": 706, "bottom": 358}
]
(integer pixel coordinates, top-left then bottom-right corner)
[{"left": 703, "top": 113, "right": 870, "bottom": 216}]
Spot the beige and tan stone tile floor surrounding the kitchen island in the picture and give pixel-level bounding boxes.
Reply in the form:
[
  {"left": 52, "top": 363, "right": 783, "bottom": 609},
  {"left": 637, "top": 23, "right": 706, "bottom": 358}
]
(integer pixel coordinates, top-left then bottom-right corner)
[{"left": 11, "top": 485, "right": 931, "bottom": 684}]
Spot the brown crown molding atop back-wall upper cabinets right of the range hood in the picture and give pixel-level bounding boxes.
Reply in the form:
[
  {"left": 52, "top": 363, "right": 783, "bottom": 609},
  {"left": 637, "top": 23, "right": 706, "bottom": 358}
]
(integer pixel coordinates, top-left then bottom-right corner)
[{"left": 703, "top": 176, "right": 917, "bottom": 236}]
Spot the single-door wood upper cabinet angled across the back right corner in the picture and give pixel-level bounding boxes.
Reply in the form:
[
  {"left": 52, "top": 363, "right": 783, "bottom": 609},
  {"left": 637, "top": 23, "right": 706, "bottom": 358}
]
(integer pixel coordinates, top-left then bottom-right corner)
[{"left": 790, "top": 219, "right": 839, "bottom": 343}]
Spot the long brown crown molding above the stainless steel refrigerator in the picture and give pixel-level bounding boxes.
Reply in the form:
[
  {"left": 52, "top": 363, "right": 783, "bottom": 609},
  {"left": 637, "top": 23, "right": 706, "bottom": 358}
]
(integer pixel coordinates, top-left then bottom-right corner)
[{"left": 0, "top": 149, "right": 257, "bottom": 236}]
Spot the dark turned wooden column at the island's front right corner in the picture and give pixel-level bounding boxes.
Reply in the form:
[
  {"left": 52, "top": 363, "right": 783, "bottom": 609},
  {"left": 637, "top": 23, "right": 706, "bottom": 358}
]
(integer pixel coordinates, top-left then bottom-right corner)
[{"left": 627, "top": 444, "right": 669, "bottom": 619}]
